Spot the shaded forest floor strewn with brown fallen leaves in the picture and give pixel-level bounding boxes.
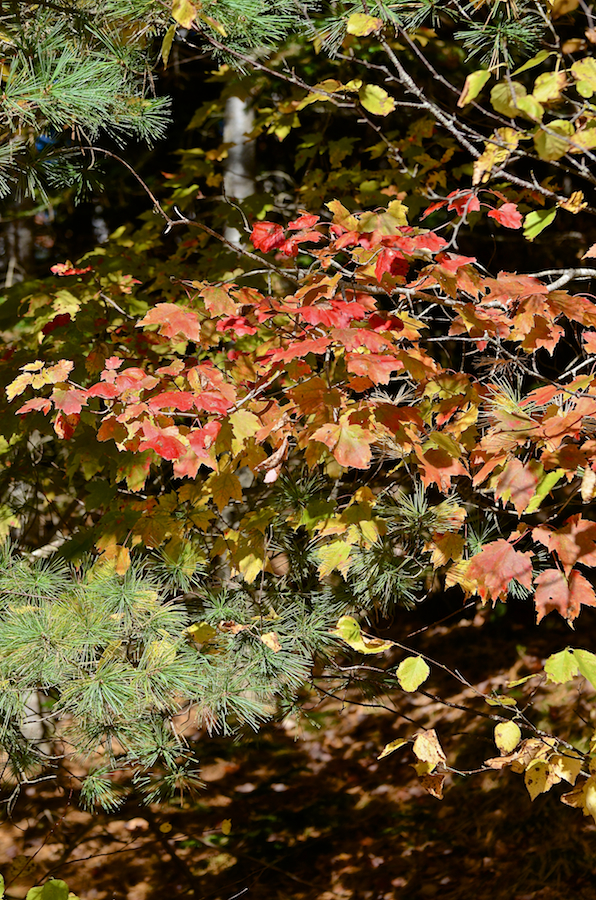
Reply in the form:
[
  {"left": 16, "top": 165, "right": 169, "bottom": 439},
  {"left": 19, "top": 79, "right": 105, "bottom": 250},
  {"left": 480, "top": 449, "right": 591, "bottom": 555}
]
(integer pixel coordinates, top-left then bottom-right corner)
[{"left": 0, "top": 596, "right": 596, "bottom": 900}]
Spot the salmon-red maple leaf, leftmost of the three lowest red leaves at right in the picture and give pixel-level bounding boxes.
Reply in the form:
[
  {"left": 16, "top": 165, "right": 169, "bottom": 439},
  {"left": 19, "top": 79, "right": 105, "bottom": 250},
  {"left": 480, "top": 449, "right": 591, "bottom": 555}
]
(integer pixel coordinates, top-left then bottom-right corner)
[{"left": 466, "top": 538, "right": 532, "bottom": 602}]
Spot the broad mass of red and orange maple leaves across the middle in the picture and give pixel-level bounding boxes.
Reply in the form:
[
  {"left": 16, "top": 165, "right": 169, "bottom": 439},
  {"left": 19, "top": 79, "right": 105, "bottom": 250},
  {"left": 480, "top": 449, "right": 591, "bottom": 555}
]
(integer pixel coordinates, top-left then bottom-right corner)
[{"left": 8, "top": 194, "right": 596, "bottom": 620}]
